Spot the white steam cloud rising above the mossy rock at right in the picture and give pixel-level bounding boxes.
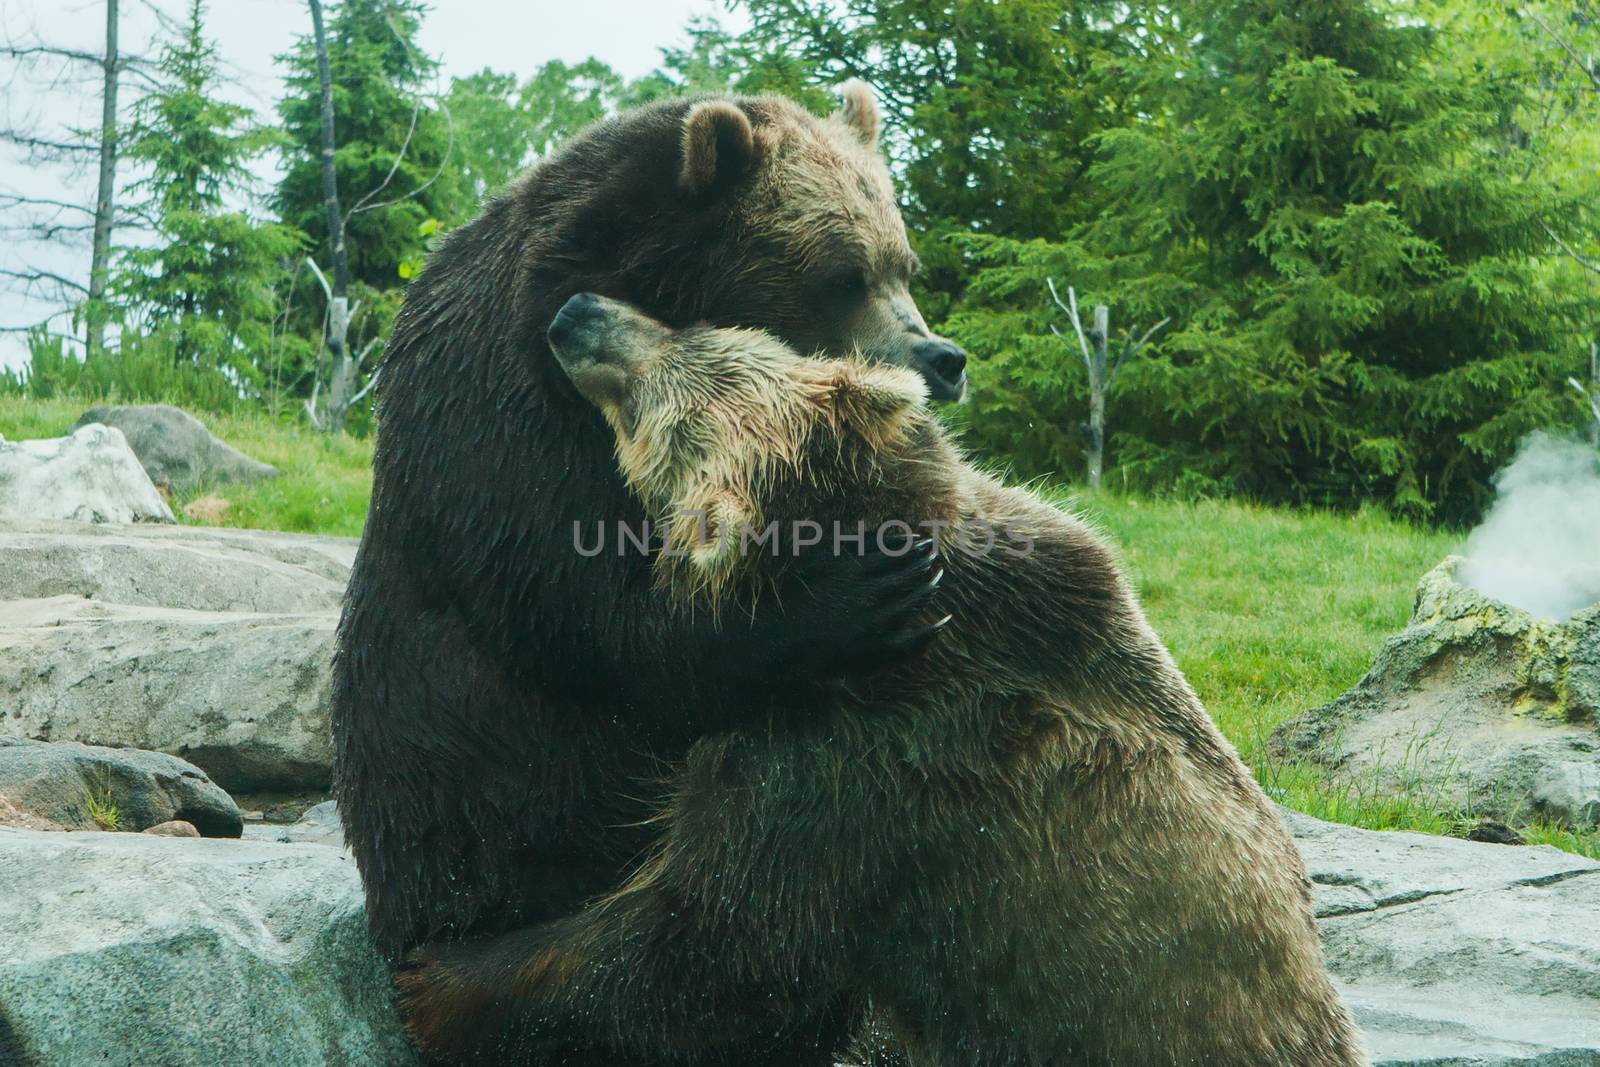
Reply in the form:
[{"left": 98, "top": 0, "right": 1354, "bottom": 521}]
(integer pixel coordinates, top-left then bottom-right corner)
[{"left": 1459, "top": 434, "right": 1600, "bottom": 619}]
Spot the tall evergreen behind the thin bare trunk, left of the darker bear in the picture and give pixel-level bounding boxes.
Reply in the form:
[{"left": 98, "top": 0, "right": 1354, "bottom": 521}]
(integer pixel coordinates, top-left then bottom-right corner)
[{"left": 277, "top": 0, "right": 460, "bottom": 290}]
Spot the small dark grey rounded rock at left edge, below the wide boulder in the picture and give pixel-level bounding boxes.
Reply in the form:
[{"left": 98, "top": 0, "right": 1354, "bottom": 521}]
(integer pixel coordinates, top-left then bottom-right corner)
[{"left": 0, "top": 737, "right": 243, "bottom": 837}]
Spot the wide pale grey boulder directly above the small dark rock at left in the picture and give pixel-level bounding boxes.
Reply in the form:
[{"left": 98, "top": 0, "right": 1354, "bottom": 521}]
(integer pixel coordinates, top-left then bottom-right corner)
[{"left": 0, "top": 597, "right": 338, "bottom": 792}]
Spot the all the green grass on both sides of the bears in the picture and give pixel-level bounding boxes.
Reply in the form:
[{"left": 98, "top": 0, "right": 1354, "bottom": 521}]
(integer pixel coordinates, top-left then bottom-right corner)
[{"left": 0, "top": 395, "right": 1600, "bottom": 856}]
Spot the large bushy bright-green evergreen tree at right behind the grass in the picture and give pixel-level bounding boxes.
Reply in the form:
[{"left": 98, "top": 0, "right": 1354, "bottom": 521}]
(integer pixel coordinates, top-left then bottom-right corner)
[{"left": 957, "top": 0, "right": 1594, "bottom": 520}]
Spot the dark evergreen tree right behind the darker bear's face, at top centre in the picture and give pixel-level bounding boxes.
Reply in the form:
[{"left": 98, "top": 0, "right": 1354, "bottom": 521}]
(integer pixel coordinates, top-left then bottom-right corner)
[{"left": 741, "top": 0, "right": 1170, "bottom": 322}]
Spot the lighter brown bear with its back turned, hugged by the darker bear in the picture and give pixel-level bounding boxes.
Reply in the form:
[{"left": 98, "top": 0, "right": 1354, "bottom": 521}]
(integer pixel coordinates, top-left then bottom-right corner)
[{"left": 403, "top": 296, "right": 1366, "bottom": 1067}]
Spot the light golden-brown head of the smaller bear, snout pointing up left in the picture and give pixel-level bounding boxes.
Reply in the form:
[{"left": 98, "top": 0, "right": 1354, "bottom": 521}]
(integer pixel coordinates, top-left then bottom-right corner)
[{"left": 549, "top": 293, "right": 931, "bottom": 603}]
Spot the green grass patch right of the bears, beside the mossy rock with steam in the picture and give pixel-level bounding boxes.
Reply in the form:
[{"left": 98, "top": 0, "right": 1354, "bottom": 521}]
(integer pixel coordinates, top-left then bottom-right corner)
[{"left": 1066, "top": 494, "right": 1497, "bottom": 833}]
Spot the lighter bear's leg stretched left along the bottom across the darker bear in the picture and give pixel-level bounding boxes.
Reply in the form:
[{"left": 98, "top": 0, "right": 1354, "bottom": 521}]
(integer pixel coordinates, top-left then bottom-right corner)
[{"left": 395, "top": 897, "right": 856, "bottom": 1067}]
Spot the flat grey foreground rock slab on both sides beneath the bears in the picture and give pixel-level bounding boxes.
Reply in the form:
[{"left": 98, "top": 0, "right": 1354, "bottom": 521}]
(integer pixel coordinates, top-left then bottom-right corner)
[{"left": 0, "top": 806, "right": 1600, "bottom": 1067}]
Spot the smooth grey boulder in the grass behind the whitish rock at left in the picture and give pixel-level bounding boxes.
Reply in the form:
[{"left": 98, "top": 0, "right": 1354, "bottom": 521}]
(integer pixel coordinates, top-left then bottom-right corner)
[{"left": 72, "top": 403, "right": 280, "bottom": 493}]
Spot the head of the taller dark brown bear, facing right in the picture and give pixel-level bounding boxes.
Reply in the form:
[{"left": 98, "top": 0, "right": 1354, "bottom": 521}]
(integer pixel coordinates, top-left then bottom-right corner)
[{"left": 514, "top": 82, "right": 966, "bottom": 400}]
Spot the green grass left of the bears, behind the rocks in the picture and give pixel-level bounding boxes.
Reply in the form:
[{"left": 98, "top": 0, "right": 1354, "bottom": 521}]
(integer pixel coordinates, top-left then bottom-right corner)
[{"left": 0, "top": 395, "right": 373, "bottom": 537}]
